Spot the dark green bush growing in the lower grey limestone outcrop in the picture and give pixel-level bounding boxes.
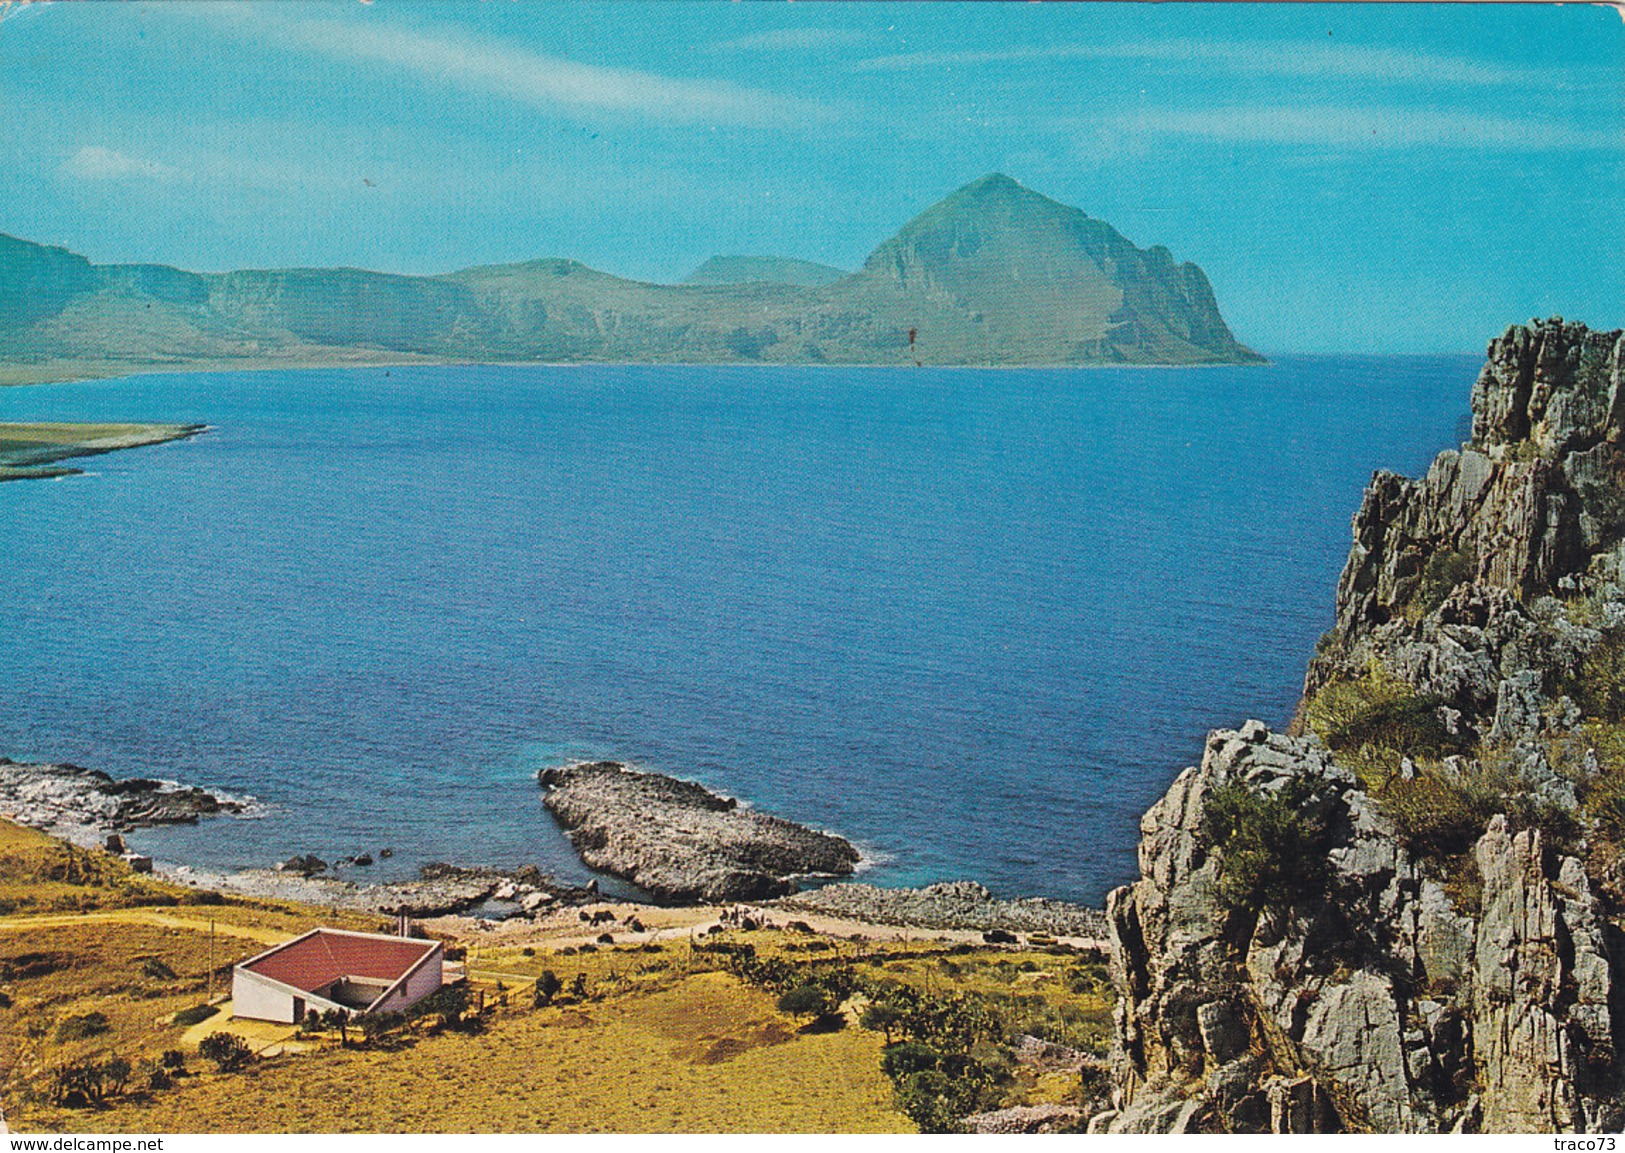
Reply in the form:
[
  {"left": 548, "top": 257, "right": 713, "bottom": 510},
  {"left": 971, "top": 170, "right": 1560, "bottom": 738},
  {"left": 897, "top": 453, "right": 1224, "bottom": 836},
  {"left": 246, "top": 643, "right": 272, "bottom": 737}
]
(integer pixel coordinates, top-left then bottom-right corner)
[{"left": 1203, "top": 776, "right": 1326, "bottom": 913}]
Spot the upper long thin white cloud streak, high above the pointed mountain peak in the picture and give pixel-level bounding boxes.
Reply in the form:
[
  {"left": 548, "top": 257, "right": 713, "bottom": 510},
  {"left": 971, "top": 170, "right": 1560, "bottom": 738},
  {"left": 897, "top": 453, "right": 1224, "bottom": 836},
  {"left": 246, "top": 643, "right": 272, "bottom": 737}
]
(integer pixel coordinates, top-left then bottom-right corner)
[{"left": 853, "top": 39, "right": 1541, "bottom": 84}]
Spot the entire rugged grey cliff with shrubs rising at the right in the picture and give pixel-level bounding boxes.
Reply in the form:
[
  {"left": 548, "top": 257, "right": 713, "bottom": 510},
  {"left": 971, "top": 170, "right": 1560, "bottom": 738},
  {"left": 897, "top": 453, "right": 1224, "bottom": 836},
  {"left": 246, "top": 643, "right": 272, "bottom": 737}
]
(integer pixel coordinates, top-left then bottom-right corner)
[{"left": 1092, "top": 320, "right": 1625, "bottom": 1132}]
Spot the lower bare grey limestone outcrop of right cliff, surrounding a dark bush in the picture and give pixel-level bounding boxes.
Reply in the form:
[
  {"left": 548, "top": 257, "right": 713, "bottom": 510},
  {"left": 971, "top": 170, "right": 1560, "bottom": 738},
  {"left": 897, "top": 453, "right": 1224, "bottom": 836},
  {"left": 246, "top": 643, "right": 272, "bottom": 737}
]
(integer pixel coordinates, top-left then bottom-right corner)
[{"left": 1097, "top": 723, "right": 1625, "bottom": 1132}]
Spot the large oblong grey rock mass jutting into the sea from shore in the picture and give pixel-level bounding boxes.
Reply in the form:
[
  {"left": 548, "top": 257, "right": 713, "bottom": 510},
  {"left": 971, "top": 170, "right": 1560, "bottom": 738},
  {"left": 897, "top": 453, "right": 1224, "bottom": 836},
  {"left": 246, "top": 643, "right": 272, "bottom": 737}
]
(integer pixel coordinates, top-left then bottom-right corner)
[{"left": 538, "top": 762, "right": 858, "bottom": 903}]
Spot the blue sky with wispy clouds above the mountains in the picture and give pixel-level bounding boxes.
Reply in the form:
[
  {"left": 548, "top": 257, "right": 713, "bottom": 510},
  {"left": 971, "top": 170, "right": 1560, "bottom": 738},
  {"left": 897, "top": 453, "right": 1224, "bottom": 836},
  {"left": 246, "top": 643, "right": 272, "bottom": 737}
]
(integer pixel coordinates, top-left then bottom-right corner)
[{"left": 0, "top": 0, "right": 1625, "bottom": 352}]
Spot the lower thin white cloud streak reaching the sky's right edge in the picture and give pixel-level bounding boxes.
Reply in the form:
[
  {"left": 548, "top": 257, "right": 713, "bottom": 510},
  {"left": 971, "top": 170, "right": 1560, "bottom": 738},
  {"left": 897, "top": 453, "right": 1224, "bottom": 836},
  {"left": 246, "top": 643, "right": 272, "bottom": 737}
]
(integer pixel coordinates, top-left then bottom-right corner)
[{"left": 1110, "top": 104, "right": 1625, "bottom": 151}]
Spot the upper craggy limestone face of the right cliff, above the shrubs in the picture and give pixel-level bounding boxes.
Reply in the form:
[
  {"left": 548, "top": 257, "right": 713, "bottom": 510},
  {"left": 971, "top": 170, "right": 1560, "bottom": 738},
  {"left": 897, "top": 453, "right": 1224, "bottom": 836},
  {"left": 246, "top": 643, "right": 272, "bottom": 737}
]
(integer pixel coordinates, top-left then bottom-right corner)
[{"left": 1305, "top": 320, "right": 1625, "bottom": 736}]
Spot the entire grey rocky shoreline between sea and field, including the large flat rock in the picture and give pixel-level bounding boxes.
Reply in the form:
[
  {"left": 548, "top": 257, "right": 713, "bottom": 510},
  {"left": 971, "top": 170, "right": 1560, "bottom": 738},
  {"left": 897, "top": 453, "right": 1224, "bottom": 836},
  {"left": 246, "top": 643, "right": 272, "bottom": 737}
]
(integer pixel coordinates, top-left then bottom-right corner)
[{"left": 0, "top": 757, "right": 1105, "bottom": 940}]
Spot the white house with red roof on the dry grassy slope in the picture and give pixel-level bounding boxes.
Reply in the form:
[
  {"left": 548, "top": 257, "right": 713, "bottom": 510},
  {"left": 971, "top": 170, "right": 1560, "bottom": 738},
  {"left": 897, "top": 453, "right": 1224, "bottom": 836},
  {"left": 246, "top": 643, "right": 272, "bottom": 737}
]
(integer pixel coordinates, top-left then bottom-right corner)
[{"left": 231, "top": 929, "right": 445, "bottom": 1025}]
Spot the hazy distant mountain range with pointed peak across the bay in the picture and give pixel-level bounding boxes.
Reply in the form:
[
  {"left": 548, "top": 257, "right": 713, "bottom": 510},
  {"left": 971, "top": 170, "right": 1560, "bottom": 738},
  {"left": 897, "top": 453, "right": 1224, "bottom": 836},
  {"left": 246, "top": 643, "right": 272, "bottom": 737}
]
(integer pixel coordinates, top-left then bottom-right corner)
[{"left": 0, "top": 175, "right": 1259, "bottom": 382}]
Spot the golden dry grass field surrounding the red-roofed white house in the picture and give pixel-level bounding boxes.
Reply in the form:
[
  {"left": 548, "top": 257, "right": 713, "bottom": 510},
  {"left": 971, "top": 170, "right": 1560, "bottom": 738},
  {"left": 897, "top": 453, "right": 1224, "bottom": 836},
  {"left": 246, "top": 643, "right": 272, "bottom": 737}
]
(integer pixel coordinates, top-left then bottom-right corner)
[{"left": 0, "top": 823, "right": 1110, "bottom": 1132}]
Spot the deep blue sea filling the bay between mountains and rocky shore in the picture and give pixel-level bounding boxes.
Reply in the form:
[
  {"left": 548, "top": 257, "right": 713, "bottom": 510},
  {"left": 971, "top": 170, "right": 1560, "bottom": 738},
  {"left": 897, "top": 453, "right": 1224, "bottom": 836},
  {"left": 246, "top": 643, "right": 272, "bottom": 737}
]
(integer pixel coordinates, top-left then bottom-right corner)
[{"left": 0, "top": 356, "right": 1479, "bottom": 901}]
